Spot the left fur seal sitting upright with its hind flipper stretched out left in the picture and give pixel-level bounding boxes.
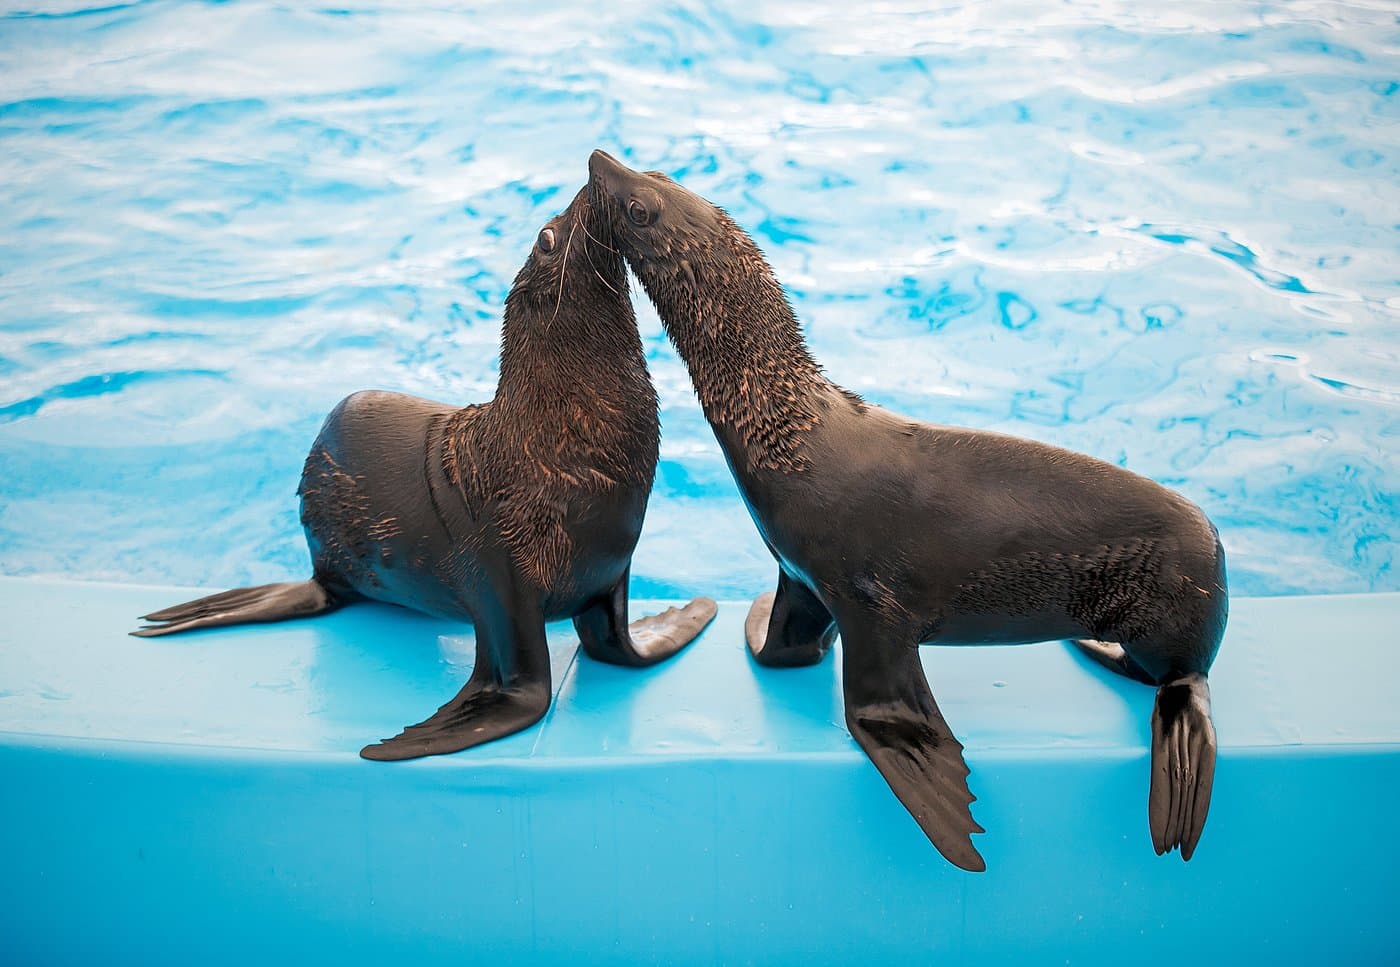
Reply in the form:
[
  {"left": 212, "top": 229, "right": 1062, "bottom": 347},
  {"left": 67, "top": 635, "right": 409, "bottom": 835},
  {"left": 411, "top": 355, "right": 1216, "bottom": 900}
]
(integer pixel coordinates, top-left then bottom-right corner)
[{"left": 133, "top": 183, "right": 715, "bottom": 760}]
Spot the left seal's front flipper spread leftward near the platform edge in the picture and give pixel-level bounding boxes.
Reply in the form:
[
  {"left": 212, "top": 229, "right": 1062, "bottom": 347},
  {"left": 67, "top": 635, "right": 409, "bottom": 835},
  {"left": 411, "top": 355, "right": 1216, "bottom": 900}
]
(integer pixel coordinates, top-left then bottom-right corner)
[{"left": 360, "top": 593, "right": 550, "bottom": 761}]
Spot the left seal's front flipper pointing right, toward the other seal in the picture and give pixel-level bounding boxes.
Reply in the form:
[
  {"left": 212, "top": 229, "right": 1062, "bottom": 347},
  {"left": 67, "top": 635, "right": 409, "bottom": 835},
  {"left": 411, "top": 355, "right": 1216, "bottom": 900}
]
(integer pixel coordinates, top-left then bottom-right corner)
[{"left": 574, "top": 568, "right": 717, "bottom": 668}]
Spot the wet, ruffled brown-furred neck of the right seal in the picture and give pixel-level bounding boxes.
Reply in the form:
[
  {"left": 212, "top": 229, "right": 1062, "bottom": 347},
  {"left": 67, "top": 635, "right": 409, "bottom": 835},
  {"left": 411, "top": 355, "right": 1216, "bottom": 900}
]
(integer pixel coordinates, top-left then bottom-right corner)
[{"left": 637, "top": 238, "right": 834, "bottom": 472}]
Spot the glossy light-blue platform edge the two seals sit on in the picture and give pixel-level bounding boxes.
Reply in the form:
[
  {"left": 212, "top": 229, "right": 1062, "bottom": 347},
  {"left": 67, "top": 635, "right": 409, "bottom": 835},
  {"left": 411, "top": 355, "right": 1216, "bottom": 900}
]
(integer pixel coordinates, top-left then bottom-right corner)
[{"left": 0, "top": 578, "right": 1400, "bottom": 967}]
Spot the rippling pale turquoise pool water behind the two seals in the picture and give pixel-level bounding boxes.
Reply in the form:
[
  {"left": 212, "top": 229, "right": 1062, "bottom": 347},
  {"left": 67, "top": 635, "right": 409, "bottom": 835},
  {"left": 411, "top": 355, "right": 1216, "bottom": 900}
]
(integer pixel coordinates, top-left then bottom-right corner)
[{"left": 0, "top": 0, "right": 1400, "bottom": 598}]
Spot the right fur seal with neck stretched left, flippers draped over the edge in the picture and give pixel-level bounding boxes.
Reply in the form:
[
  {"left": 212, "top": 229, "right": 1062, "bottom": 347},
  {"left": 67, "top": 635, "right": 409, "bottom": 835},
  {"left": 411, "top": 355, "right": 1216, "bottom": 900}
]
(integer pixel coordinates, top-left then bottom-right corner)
[{"left": 589, "top": 151, "right": 1228, "bottom": 870}]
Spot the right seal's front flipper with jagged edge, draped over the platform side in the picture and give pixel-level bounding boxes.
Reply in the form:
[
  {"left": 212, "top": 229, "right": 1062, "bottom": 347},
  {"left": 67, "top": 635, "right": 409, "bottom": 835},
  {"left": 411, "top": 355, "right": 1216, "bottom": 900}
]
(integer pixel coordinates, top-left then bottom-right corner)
[{"left": 841, "top": 631, "right": 987, "bottom": 873}]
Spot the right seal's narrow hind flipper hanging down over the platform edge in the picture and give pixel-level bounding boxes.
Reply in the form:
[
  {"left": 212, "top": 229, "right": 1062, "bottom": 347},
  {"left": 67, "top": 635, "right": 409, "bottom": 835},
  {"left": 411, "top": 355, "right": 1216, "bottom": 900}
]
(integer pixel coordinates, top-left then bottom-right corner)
[{"left": 1148, "top": 673, "right": 1215, "bottom": 859}]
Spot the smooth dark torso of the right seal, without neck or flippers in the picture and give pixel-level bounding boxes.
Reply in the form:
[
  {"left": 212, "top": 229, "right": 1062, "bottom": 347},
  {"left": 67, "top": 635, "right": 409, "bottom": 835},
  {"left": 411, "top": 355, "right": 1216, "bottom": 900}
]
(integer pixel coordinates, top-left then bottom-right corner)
[{"left": 744, "top": 405, "right": 1225, "bottom": 677}]
